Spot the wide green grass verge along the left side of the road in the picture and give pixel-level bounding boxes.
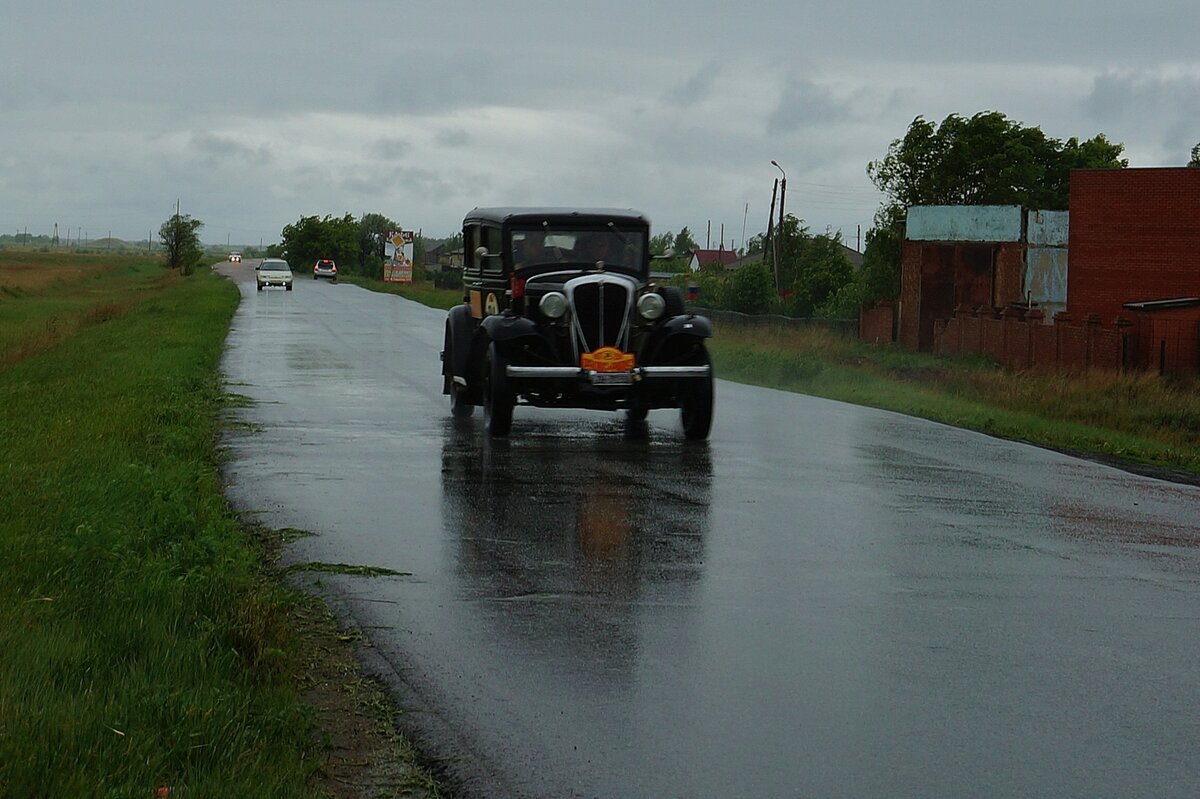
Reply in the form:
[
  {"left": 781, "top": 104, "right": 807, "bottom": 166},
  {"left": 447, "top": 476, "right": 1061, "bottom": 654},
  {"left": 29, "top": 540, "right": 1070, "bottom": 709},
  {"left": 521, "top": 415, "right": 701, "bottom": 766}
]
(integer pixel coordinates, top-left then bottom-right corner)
[{"left": 0, "top": 257, "right": 437, "bottom": 798}]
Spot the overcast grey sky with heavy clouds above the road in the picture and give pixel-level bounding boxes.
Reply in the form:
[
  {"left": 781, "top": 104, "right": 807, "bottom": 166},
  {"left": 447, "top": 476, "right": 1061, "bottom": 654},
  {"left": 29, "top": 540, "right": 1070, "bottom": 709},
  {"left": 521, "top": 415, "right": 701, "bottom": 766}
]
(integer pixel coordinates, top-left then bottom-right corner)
[{"left": 0, "top": 0, "right": 1200, "bottom": 247}]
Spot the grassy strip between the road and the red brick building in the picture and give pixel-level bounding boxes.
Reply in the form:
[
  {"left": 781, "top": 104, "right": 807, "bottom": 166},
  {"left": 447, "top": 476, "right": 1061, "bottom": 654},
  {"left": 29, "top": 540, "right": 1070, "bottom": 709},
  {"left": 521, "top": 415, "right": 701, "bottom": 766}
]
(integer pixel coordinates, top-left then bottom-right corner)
[{"left": 710, "top": 325, "right": 1200, "bottom": 474}]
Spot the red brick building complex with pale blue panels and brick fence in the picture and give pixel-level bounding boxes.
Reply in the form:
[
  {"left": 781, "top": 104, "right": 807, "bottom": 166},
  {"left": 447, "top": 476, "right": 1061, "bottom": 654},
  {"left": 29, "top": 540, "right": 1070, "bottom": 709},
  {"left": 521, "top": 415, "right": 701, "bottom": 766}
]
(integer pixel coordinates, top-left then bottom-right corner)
[{"left": 899, "top": 167, "right": 1200, "bottom": 374}]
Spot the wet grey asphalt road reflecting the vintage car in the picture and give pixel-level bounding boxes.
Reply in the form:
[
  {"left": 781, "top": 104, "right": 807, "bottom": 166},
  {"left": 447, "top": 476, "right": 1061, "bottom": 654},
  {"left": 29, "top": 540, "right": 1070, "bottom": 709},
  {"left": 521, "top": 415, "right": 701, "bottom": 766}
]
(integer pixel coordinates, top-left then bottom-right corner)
[{"left": 221, "top": 262, "right": 1200, "bottom": 799}]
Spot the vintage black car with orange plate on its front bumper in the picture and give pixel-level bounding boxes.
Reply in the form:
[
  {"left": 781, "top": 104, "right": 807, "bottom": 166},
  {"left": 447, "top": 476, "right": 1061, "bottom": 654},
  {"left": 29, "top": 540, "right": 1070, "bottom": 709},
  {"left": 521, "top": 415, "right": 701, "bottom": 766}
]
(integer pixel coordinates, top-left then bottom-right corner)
[{"left": 442, "top": 208, "right": 713, "bottom": 439}]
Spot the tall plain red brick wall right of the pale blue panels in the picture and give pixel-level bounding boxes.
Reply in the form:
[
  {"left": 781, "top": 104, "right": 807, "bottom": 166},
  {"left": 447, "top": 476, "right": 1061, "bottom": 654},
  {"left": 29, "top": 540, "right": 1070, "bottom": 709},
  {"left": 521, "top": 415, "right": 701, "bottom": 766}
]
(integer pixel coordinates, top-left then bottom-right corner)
[{"left": 1067, "top": 167, "right": 1200, "bottom": 324}]
